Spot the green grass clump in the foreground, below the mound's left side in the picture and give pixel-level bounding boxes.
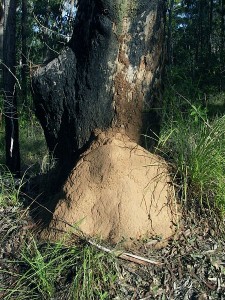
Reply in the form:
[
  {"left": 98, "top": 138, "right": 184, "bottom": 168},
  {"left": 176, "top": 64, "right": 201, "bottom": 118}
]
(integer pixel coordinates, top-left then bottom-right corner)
[{"left": 0, "top": 238, "right": 116, "bottom": 300}]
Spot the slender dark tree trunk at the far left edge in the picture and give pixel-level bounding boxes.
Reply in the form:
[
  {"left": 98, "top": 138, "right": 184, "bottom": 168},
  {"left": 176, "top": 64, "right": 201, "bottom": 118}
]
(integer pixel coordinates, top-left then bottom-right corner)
[{"left": 3, "top": 0, "right": 20, "bottom": 175}]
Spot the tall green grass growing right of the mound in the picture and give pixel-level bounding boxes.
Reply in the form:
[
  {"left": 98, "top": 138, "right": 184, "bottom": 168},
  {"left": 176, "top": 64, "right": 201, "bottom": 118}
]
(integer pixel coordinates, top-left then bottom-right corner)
[{"left": 158, "top": 97, "right": 225, "bottom": 215}]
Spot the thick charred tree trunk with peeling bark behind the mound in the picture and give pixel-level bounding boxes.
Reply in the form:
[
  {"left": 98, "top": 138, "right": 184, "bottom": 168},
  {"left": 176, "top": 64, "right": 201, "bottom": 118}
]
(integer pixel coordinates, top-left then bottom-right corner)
[{"left": 32, "top": 0, "right": 165, "bottom": 169}]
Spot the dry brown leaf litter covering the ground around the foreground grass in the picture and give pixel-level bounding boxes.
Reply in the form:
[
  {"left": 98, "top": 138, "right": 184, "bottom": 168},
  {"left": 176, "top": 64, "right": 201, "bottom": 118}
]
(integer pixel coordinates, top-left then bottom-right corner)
[{"left": 0, "top": 202, "right": 225, "bottom": 300}]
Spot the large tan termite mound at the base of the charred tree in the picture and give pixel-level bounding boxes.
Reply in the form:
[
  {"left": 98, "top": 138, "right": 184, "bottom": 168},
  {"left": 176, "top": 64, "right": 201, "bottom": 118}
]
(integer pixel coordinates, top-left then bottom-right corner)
[{"left": 45, "top": 132, "right": 176, "bottom": 243}]
